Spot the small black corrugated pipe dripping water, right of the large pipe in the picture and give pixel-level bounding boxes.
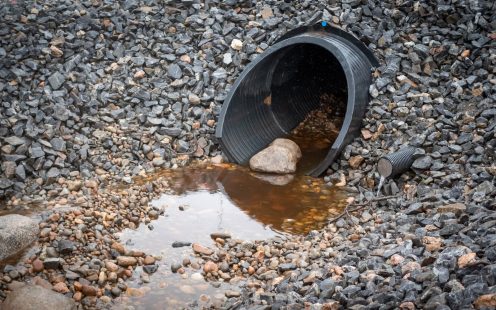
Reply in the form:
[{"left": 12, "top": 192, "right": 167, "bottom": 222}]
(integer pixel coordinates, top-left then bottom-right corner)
[{"left": 377, "top": 146, "right": 416, "bottom": 178}]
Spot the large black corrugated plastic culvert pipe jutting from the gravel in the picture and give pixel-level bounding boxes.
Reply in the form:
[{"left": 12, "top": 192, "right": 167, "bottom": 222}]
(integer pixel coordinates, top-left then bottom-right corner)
[{"left": 216, "top": 22, "right": 378, "bottom": 176}]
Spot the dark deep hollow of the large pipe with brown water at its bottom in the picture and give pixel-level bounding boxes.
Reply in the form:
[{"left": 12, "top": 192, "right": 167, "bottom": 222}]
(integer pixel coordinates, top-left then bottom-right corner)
[{"left": 270, "top": 44, "right": 348, "bottom": 173}]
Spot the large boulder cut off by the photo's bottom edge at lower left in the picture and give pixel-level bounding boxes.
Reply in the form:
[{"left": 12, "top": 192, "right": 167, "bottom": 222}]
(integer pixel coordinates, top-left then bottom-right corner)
[{"left": 0, "top": 284, "right": 76, "bottom": 310}]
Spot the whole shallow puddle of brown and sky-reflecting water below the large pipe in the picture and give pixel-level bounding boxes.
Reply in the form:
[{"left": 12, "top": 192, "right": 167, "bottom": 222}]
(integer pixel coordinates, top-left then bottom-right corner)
[{"left": 111, "top": 164, "right": 347, "bottom": 309}]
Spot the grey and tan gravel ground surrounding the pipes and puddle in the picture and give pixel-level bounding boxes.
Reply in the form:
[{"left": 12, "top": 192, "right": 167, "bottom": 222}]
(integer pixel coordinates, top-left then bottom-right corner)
[{"left": 0, "top": 0, "right": 496, "bottom": 309}]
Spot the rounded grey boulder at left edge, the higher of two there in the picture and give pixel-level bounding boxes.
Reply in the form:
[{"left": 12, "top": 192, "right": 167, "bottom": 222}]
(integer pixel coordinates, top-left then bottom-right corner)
[{"left": 0, "top": 214, "right": 39, "bottom": 261}]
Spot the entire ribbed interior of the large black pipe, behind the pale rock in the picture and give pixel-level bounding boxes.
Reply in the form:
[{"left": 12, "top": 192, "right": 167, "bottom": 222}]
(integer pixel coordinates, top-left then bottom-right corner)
[{"left": 224, "top": 43, "right": 347, "bottom": 173}]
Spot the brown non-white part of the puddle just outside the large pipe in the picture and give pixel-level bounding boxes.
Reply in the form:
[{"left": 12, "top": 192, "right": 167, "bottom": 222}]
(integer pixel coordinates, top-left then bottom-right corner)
[{"left": 134, "top": 165, "right": 346, "bottom": 234}]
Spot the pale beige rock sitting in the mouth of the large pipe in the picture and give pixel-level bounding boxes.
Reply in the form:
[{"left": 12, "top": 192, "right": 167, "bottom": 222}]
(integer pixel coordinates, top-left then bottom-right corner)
[{"left": 250, "top": 139, "right": 301, "bottom": 174}]
